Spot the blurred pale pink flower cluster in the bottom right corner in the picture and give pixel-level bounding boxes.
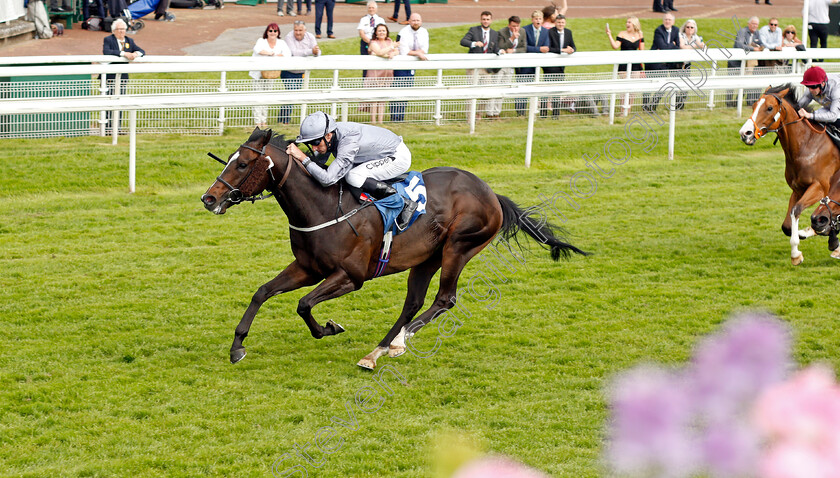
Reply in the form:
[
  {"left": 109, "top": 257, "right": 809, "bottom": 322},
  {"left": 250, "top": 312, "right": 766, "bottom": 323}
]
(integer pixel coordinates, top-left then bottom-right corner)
[{"left": 754, "top": 366, "right": 840, "bottom": 478}]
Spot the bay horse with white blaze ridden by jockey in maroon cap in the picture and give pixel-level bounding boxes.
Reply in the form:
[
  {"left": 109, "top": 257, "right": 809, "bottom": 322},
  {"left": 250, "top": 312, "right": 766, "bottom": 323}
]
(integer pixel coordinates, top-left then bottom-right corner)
[{"left": 739, "top": 84, "right": 840, "bottom": 265}]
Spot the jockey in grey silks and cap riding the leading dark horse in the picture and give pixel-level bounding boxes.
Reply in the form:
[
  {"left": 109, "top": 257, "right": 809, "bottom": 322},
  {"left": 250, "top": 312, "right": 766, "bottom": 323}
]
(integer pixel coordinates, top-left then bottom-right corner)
[{"left": 286, "top": 111, "right": 417, "bottom": 229}]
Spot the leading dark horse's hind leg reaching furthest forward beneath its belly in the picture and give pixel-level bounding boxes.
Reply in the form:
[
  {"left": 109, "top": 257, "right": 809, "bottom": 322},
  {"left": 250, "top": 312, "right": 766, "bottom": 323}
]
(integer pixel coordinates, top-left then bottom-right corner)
[{"left": 357, "top": 255, "right": 440, "bottom": 370}]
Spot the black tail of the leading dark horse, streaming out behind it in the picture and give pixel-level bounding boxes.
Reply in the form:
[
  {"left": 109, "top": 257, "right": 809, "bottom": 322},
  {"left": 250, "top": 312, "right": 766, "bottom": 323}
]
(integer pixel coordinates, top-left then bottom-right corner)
[{"left": 496, "top": 194, "right": 589, "bottom": 261}]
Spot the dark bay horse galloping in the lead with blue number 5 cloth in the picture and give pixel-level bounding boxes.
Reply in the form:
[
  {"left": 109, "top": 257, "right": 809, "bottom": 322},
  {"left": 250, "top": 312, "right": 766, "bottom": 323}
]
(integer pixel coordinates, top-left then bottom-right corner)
[{"left": 201, "top": 128, "right": 586, "bottom": 369}]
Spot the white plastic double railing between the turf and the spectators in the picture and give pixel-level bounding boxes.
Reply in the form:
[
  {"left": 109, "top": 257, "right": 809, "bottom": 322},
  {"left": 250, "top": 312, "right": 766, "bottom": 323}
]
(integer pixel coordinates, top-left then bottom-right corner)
[{"left": 0, "top": 48, "right": 840, "bottom": 191}]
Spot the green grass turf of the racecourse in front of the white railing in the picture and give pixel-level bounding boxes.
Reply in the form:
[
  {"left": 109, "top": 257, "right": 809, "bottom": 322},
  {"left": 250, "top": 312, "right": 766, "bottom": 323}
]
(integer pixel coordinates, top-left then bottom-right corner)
[{"left": 0, "top": 110, "right": 840, "bottom": 477}]
